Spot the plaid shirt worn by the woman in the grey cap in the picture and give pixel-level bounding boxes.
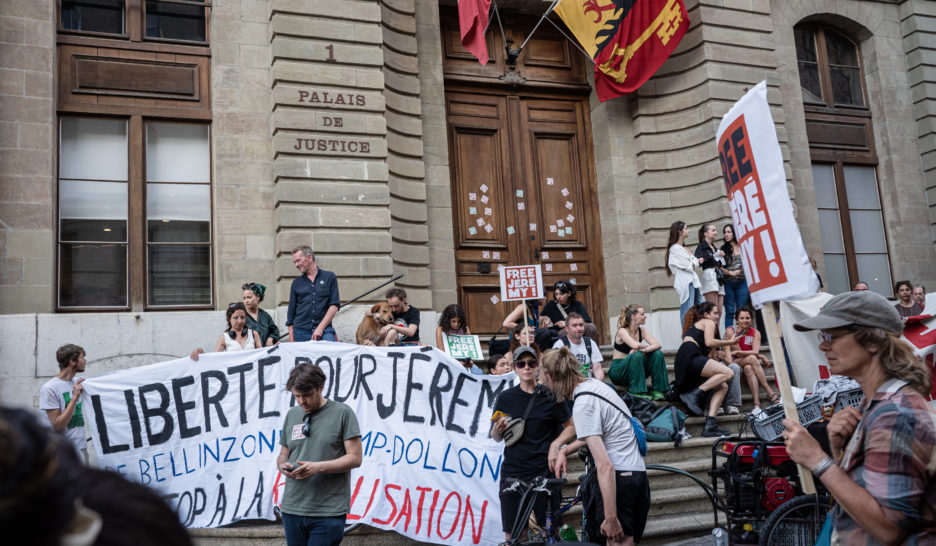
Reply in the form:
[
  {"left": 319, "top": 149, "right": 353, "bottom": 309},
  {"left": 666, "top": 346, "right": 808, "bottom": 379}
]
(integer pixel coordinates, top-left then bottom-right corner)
[{"left": 832, "top": 379, "right": 936, "bottom": 546}]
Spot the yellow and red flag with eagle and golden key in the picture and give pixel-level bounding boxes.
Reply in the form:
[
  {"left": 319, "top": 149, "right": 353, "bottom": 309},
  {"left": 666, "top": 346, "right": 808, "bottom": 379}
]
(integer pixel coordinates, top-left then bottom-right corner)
[{"left": 556, "top": 0, "right": 689, "bottom": 102}]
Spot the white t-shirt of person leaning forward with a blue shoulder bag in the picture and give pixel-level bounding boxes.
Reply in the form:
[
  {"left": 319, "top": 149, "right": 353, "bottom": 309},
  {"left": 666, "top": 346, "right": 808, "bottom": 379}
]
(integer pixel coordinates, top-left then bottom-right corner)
[{"left": 572, "top": 379, "right": 647, "bottom": 471}]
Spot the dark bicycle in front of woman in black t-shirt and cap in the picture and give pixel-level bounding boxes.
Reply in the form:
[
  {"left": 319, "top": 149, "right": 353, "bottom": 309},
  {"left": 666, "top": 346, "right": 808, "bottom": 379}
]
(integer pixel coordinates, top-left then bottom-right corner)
[{"left": 501, "top": 476, "right": 584, "bottom": 546}]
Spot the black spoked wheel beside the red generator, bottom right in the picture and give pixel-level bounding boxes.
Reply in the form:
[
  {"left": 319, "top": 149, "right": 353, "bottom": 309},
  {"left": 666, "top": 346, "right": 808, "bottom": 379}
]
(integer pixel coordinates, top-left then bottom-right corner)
[{"left": 760, "top": 495, "right": 830, "bottom": 546}]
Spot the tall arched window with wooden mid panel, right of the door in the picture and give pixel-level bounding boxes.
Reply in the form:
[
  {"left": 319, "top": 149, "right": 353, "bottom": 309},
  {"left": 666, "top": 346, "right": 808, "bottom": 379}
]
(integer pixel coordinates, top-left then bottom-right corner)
[{"left": 794, "top": 23, "right": 893, "bottom": 296}]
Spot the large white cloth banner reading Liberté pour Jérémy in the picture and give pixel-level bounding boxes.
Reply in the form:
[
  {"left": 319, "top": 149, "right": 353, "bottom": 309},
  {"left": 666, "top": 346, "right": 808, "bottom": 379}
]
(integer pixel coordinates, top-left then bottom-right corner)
[{"left": 83, "top": 342, "right": 516, "bottom": 544}]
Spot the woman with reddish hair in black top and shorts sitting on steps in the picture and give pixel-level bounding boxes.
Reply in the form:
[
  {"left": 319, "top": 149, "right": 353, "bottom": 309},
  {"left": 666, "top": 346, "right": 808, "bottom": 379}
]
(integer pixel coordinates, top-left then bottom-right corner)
[{"left": 675, "top": 301, "right": 738, "bottom": 437}]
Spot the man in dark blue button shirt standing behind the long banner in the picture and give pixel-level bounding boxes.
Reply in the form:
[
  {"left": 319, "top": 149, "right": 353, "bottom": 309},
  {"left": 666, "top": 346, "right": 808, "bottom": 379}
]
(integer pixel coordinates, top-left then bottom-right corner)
[{"left": 286, "top": 246, "right": 339, "bottom": 341}]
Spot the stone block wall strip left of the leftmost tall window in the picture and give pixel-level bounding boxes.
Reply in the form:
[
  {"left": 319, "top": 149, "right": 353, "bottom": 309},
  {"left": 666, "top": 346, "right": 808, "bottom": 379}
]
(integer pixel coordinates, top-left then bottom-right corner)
[{"left": 0, "top": 0, "right": 56, "bottom": 314}]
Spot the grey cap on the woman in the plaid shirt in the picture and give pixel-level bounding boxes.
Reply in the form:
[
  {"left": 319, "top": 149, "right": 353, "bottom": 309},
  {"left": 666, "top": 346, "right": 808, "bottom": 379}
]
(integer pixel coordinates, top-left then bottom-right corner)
[{"left": 793, "top": 290, "right": 903, "bottom": 335}]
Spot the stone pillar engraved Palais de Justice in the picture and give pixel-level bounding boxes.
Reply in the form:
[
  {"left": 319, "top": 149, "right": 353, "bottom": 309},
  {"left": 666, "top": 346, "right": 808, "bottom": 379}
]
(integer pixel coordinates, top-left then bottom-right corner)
[{"left": 270, "top": 0, "right": 393, "bottom": 304}]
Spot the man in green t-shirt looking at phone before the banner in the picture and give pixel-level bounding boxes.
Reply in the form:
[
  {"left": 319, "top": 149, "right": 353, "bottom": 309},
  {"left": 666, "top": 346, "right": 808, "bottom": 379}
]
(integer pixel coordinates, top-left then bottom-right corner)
[{"left": 276, "top": 363, "right": 361, "bottom": 546}]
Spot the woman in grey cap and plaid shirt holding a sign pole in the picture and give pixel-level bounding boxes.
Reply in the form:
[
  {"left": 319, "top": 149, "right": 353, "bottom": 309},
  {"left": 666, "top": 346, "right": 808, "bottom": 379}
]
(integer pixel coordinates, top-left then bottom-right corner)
[{"left": 783, "top": 290, "right": 936, "bottom": 544}]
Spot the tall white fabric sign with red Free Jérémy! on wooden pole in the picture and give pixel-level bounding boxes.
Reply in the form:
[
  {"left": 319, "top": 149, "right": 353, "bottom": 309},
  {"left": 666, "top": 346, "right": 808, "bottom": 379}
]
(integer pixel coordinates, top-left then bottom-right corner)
[{"left": 716, "top": 81, "right": 819, "bottom": 308}]
